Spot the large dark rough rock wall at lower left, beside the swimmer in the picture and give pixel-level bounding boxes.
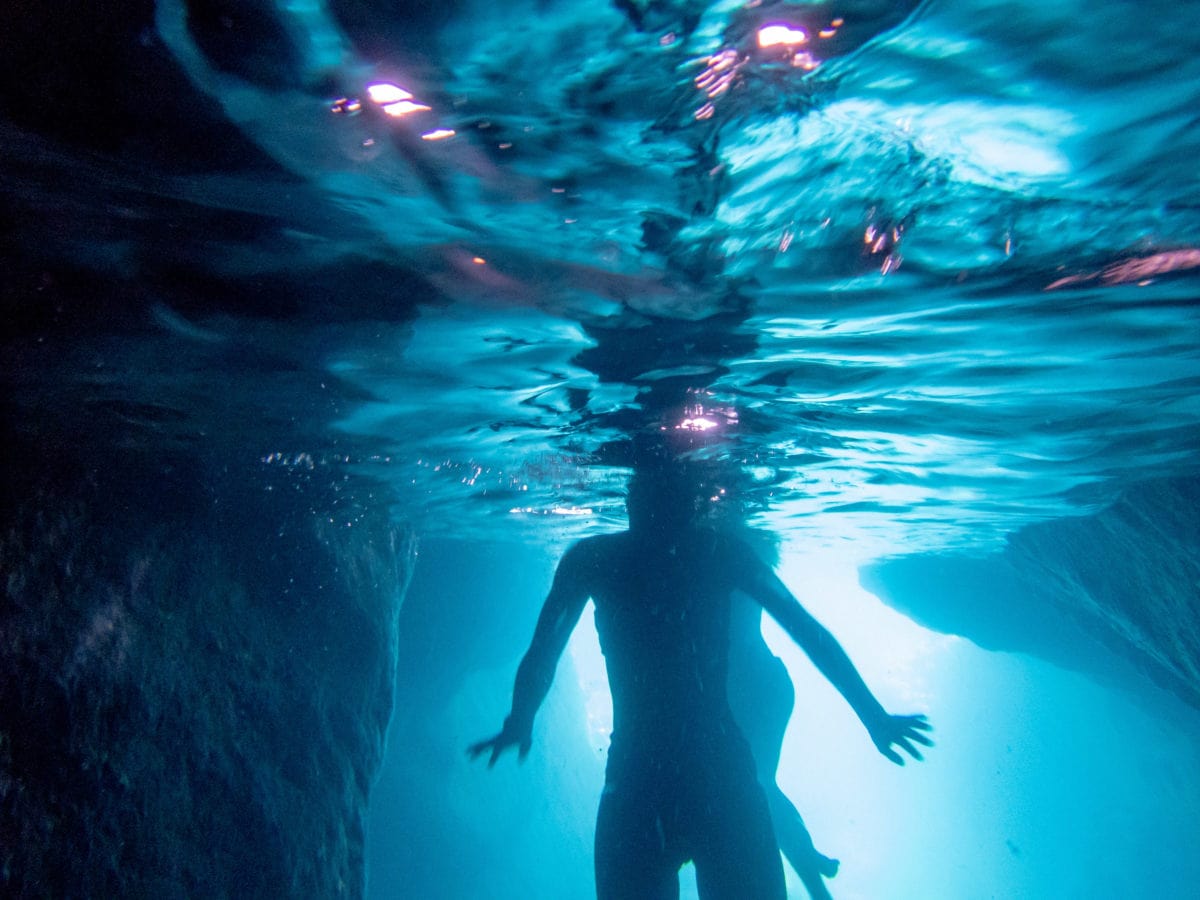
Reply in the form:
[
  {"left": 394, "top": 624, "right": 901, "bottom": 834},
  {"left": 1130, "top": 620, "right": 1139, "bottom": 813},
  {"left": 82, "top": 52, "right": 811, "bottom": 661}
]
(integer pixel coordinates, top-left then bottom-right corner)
[{"left": 0, "top": 454, "right": 413, "bottom": 898}]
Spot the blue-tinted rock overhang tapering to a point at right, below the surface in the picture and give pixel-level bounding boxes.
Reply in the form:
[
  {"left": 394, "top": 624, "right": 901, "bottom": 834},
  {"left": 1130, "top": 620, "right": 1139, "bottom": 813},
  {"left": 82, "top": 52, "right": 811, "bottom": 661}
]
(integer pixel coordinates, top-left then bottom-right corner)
[{"left": 860, "top": 479, "right": 1200, "bottom": 707}]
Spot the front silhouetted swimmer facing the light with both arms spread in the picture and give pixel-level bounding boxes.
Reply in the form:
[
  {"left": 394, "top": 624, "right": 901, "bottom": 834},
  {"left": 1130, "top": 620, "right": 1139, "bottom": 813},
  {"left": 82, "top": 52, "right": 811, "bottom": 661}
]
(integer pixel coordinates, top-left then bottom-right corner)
[{"left": 469, "top": 472, "right": 930, "bottom": 900}]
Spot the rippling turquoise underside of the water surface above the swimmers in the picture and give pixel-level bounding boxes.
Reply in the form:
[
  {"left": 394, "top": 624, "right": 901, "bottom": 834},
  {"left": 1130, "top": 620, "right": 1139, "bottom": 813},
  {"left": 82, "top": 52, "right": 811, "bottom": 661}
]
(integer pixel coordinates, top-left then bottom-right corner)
[{"left": 6, "top": 0, "right": 1200, "bottom": 557}]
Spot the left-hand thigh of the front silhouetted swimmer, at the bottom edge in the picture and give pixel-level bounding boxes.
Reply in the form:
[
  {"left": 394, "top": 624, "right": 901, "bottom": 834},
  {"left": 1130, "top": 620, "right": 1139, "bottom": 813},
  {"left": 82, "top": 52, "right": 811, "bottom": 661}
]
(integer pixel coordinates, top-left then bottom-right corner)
[{"left": 595, "top": 788, "right": 681, "bottom": 900}]
